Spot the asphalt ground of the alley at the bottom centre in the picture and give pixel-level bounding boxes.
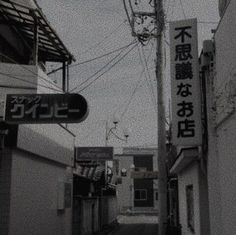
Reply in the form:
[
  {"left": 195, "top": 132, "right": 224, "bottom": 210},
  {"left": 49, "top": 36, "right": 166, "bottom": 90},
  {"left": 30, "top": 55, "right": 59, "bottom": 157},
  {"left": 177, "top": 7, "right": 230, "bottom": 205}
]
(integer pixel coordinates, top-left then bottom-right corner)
[{"left": 110, "top": 215, "right": 158, "bottom": 235}]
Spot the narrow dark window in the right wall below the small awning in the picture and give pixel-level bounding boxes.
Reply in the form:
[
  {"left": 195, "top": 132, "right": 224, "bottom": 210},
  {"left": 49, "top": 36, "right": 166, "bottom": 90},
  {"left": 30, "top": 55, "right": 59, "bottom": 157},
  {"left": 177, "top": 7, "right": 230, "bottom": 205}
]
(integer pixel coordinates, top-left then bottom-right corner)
[{"left": 186, "top": 185, "right": 194, "bottom": 232}]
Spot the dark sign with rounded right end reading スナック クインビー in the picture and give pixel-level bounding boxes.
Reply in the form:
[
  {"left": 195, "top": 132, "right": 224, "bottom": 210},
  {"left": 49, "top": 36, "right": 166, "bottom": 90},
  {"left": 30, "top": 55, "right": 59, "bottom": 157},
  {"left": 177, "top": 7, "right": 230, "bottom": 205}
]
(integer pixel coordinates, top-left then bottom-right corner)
[{"left": 5, "top": 94, "right": 88, "bottom": 124}]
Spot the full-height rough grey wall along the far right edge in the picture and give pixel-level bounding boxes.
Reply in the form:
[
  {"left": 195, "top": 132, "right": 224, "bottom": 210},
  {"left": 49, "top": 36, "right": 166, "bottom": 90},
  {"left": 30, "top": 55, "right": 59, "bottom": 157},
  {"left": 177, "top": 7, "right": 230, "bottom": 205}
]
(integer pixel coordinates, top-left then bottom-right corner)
[{"left": 208, "top": 1, "right": 236, "bottom": 235}]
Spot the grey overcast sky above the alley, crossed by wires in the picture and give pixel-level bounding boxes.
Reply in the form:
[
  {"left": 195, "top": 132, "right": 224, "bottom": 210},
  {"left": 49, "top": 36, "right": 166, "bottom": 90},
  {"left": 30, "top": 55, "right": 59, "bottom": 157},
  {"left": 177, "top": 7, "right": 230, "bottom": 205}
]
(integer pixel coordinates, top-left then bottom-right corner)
[{"left": 37, "top": 0, "right": 219, "bottom": 150}]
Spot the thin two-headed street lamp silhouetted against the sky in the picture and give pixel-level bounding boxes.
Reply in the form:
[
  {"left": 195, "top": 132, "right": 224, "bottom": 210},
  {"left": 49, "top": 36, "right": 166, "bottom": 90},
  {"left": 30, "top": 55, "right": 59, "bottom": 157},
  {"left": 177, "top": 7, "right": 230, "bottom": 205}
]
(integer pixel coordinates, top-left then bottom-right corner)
[{"left": 105, "top": 115, "right": 130, "bottom": 146}]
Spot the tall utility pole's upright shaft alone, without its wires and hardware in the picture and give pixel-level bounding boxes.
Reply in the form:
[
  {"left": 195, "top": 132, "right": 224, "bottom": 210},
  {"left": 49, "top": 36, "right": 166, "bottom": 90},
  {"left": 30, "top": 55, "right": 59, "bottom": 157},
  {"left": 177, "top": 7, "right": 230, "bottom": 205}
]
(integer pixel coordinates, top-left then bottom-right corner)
[{"left": 154, "top": 0, "right": 167, "bottom": 235}]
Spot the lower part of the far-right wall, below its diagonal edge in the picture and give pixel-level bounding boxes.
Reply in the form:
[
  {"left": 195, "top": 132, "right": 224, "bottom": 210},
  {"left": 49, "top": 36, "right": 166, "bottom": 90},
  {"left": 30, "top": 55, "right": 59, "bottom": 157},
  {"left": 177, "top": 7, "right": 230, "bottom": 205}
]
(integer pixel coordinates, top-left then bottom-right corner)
[{"left": 216, "top": 114, "right": 236, "bottom": 235}]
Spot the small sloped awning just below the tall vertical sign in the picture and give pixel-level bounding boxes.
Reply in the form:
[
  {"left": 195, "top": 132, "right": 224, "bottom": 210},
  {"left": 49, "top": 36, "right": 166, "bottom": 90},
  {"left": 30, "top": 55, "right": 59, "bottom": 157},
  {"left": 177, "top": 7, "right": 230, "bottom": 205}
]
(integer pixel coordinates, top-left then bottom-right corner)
[{"left": 170, "top": 148, "right": 199, "bottom": 174}]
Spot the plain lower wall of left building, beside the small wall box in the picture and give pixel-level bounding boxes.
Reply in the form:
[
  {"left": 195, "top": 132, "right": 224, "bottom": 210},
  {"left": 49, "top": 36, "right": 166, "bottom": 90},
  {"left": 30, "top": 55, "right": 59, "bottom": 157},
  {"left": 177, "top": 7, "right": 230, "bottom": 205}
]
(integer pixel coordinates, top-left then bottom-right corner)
[{"left": 9, "top": 150, "right": 72, "bottom": 235}]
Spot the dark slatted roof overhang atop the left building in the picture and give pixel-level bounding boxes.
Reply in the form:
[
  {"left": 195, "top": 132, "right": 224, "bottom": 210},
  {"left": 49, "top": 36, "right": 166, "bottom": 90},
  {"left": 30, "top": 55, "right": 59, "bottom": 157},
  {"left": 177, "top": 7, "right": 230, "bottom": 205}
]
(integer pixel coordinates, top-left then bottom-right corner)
[{"left": 0, "top": 0, "right": 75, "bottom": 63}]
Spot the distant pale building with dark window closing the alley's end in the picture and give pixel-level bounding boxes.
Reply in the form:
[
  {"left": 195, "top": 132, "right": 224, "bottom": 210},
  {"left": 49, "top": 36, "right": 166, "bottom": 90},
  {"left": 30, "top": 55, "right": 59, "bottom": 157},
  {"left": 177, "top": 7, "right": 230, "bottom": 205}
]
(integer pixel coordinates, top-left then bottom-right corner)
[{"left": 114, "top": 148, "right": 158, "bottom": 213}]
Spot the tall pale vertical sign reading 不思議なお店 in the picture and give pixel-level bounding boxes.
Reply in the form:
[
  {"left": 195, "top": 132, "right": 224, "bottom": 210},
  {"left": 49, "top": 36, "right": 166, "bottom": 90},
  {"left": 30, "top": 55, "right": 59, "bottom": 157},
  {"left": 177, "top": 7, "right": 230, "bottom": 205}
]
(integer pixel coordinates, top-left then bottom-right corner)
[{"left": 170, "top": 19, "right": 202, "bottom": 146}]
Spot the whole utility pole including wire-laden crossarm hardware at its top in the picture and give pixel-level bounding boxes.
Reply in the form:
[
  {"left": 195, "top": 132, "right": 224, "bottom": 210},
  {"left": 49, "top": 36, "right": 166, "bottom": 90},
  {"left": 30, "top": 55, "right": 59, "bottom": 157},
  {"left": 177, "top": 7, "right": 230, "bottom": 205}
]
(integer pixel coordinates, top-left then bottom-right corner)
[{"left": 123, "top": 0, "right": 167, "bottom": 232}]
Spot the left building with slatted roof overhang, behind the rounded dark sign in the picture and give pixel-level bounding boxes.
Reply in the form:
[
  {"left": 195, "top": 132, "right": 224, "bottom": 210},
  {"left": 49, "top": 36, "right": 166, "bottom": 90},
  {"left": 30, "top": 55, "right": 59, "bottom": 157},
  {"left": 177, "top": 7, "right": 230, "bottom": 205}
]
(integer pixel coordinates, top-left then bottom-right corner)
[{"left": 0, "top": 0, "right": 75, "bottom": 235}]
